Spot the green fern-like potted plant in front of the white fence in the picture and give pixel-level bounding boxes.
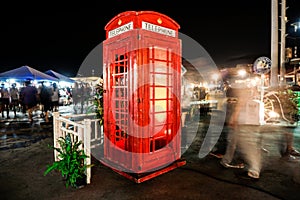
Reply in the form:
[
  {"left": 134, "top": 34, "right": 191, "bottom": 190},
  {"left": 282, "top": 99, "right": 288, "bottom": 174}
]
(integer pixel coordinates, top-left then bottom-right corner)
[{"left": 44, "top": 134, "right": 92, "bottom": 188}]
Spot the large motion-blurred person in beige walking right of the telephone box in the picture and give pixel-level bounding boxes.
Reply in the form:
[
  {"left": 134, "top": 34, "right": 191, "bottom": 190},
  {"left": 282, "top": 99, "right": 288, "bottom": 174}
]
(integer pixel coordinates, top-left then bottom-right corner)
[{"left": 220, "top": 83, "right": 261, "bottom": 179}]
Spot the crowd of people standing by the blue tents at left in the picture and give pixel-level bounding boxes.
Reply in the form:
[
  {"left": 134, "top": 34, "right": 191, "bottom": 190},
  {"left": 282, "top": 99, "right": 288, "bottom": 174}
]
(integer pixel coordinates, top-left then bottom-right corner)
[{"left": 0, "top": 80, "right": 92, "bottom": 122}]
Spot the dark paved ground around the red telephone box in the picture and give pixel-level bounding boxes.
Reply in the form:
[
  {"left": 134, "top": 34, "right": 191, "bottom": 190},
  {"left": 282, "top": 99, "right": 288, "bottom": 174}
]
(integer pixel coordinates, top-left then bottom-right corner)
[{"left": 0, "top": 108, "right": 300, "bottom": 200}]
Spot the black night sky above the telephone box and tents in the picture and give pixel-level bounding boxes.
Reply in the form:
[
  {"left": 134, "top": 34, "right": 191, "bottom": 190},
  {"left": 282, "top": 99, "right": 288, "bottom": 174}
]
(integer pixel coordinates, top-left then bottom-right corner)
[{"left": 0, "top": 0, "right": 300, "bottom": 77}]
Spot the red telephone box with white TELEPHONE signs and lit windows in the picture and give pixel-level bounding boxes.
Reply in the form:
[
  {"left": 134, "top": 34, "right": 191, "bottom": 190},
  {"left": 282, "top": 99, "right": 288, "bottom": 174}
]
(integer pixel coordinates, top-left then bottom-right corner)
[{"left": 102, "top": 11, "right": 185, "bottom": 183}]
